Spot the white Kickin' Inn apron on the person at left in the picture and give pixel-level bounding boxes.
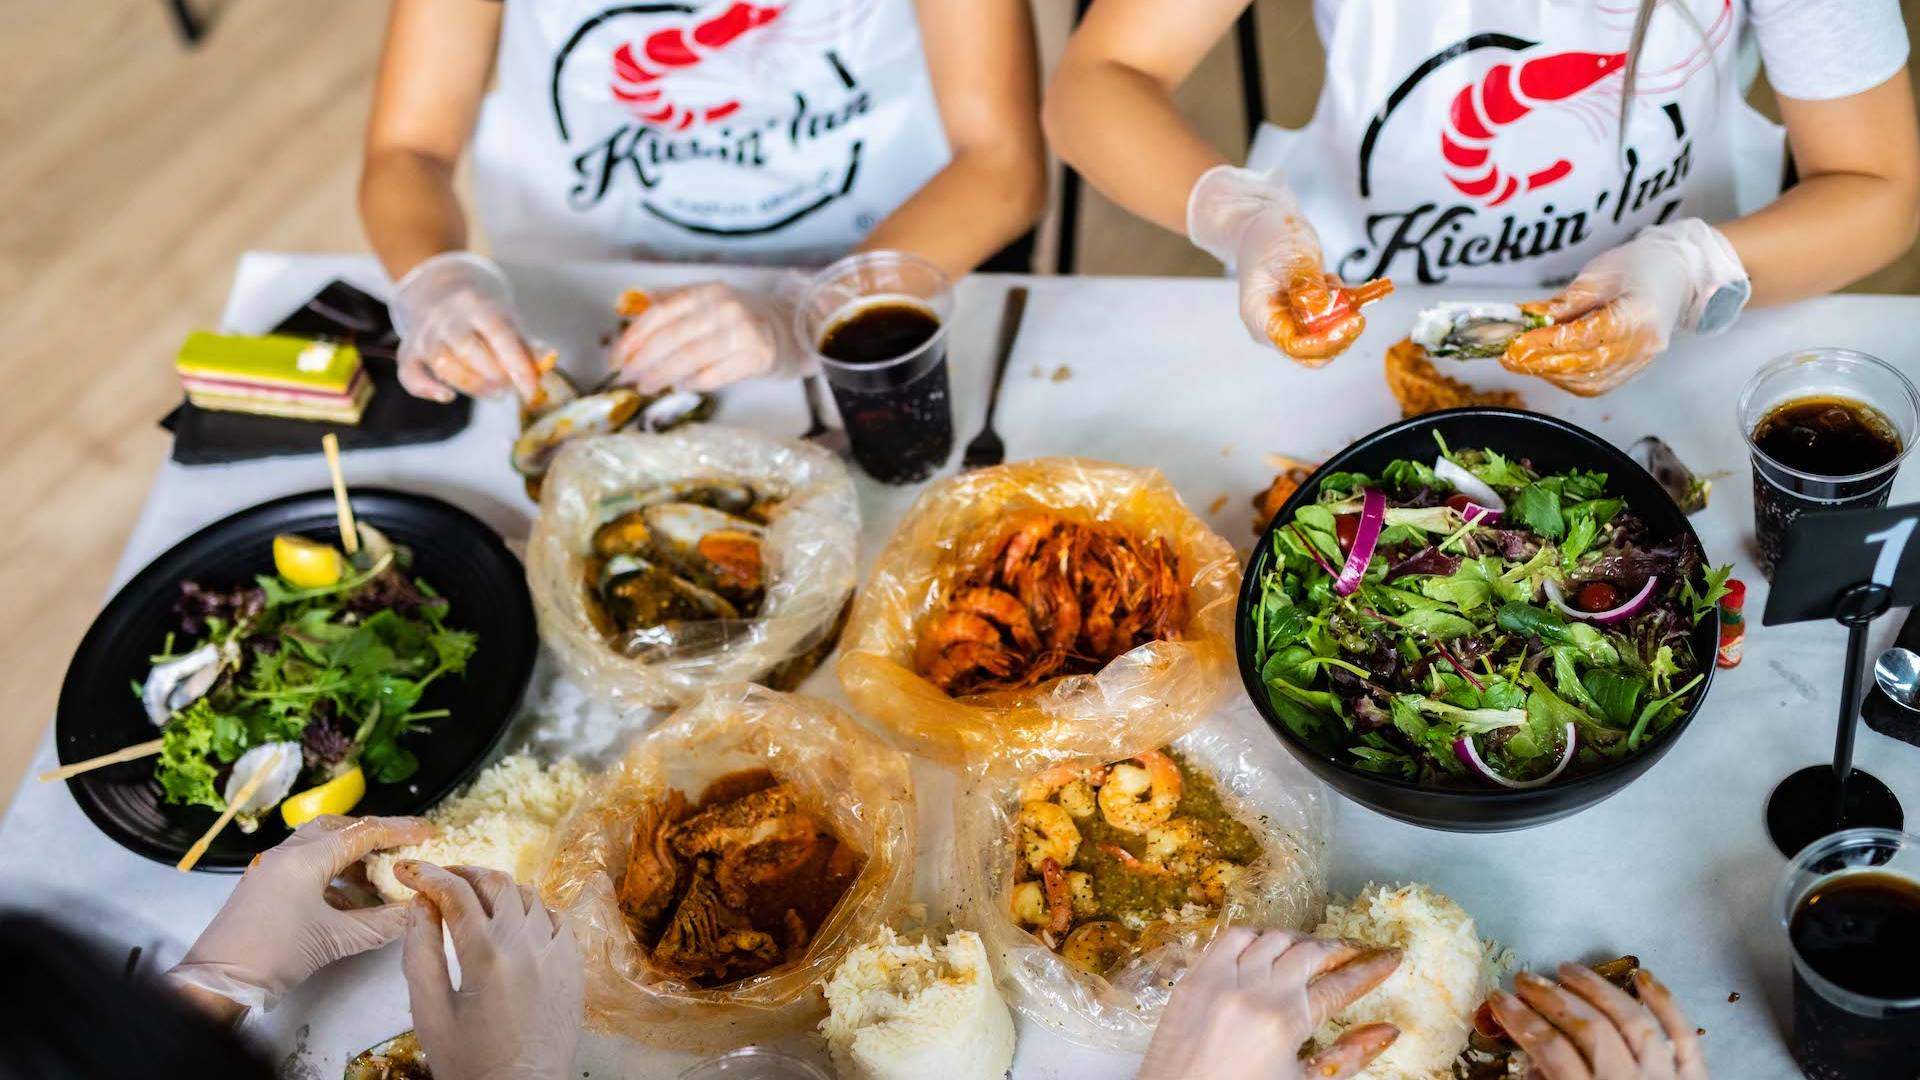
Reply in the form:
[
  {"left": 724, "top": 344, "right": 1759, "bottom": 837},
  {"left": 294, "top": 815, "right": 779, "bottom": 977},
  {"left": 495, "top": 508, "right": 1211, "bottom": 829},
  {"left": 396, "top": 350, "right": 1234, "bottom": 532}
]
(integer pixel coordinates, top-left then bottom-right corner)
[{"left": 474, "top": 0, "right": 948, "bottom": 265}]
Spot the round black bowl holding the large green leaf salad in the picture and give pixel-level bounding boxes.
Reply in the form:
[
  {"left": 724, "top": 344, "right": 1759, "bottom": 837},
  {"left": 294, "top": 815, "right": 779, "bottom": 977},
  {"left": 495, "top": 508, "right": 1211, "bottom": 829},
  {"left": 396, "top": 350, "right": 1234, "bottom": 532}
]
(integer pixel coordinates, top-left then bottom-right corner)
[{"left": 1235, "top": 407, "right": 1720, "bottom": 832}]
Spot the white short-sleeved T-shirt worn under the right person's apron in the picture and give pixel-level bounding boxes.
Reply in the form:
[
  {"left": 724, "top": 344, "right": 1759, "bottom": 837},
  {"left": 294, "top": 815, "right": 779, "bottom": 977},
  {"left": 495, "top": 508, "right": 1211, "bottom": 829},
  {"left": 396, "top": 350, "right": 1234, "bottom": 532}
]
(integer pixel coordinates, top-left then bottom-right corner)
[{"left": 1313, "top": 0, "right": 1907, "bottom": 102}]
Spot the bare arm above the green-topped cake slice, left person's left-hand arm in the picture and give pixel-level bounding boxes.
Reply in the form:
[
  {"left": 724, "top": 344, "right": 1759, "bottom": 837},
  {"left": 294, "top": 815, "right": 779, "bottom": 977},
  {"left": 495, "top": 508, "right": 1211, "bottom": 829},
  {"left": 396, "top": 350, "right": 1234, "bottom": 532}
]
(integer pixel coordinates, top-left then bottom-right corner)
[{"left": 359, "top": 0, "right": 501, "bottom": 281}]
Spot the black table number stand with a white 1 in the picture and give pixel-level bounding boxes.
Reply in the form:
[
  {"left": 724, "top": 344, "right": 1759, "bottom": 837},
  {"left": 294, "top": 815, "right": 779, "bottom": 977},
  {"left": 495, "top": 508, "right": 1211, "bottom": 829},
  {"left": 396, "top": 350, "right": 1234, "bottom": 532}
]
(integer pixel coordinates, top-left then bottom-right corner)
[{"left": 1761, "top": 503, "right": 1920, "bottom": 859}]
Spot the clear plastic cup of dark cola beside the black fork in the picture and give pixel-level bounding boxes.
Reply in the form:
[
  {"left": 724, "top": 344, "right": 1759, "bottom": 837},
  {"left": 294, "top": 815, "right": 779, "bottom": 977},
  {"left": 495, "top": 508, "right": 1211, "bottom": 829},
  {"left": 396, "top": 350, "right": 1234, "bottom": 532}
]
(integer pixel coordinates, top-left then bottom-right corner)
[{"left": 793, "top": 252, "right": 954, "bottom": 484}]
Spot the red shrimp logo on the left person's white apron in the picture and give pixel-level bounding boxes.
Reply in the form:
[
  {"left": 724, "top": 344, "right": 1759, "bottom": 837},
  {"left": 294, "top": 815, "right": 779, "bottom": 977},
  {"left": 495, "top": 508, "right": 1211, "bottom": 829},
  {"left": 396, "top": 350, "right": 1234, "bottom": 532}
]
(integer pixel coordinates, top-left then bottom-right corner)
[{"left": 611, "top": 0, "right": 785, "bottom": 131}]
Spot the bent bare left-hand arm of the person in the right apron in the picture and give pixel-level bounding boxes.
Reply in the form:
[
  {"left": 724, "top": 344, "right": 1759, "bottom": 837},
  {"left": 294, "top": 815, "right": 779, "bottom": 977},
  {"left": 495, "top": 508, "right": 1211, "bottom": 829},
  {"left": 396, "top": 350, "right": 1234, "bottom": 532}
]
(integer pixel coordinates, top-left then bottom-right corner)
[{"left": 1044, "top": 0, "right": 1248, "bottom": 236}]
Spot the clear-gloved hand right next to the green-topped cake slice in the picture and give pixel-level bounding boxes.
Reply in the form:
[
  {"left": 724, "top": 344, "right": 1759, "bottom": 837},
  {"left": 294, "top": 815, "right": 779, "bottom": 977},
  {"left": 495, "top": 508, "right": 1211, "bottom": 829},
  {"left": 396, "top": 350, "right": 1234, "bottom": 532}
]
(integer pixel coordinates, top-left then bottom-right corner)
[{"left": 390, "top": 252, "right": 551, "bottom": 402}]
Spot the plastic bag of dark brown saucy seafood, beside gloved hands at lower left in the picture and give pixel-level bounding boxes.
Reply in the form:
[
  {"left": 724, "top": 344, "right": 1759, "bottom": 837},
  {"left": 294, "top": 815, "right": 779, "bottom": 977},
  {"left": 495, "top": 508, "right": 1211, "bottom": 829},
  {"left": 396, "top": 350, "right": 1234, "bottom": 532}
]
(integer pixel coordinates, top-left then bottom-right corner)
[{"left": 540, "top": 684, "right": 914, "bottom": 1051}]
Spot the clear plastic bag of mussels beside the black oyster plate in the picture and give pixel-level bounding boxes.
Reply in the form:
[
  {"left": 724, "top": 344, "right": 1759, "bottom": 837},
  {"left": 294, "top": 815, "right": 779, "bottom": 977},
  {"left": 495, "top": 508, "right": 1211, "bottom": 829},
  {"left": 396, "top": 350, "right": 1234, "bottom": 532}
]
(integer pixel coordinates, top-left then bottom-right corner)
[{"left": 526, "top": 425, "right": 860, "bottom": 709}]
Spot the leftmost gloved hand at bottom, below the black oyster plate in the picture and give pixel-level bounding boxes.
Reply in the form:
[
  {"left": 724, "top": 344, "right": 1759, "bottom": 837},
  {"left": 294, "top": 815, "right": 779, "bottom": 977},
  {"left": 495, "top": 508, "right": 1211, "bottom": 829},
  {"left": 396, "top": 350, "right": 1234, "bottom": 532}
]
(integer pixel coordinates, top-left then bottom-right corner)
[{"left": 167, "top": 815, "right": 434, "bottom": 1007}]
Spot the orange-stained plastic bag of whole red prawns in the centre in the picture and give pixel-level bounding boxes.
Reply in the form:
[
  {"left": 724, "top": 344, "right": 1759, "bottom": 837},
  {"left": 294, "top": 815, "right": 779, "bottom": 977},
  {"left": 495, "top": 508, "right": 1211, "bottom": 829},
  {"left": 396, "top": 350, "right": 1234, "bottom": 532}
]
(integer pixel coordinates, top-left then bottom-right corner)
[{"left": 839, "top": 457, "right": 1240, "bottom": 763}]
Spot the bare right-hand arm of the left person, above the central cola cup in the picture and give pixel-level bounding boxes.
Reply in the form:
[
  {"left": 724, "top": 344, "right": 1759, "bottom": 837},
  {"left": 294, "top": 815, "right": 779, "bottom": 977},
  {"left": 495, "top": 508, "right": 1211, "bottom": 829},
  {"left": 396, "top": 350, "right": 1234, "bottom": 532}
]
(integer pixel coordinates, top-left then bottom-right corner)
[{"left": 860, "top": 0, "right": 1046, "bottom": 277}]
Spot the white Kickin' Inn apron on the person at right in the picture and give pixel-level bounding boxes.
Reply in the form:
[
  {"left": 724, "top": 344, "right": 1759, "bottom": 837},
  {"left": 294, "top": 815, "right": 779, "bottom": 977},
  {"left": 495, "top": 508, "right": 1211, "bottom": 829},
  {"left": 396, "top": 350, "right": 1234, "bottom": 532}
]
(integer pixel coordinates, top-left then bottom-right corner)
[{"left": 1248, "top": 0, "right": 1782, "bottom": 286}]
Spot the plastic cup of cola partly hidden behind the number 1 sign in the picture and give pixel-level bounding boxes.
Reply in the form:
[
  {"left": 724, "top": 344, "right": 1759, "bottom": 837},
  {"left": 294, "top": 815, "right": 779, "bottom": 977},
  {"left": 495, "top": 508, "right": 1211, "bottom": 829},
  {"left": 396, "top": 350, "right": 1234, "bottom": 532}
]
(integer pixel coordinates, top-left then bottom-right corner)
[{"left": 1740, "top": 348, "right": 1920, "bottom": 580}]
